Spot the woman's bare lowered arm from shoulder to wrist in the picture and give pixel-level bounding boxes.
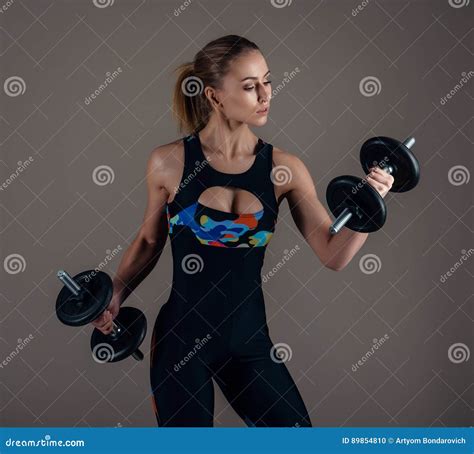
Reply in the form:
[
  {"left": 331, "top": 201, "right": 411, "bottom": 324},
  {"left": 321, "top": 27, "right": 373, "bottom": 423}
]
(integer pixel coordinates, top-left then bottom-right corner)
[{"left": 113, "top": 148, "right": 169, "bottom": 303}]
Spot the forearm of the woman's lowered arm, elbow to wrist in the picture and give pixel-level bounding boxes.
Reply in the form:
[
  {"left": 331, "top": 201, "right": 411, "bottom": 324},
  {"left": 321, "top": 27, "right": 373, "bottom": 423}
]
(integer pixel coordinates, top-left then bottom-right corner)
[{"left": 113, "top": 235, "right": 166, "bottom": 304}]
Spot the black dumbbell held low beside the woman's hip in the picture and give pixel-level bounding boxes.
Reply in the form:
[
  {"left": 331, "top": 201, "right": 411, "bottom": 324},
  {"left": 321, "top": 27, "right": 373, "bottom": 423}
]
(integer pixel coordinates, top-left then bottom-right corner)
[{"left": 56, "top": 270, "right": 146, "bottom": 363}]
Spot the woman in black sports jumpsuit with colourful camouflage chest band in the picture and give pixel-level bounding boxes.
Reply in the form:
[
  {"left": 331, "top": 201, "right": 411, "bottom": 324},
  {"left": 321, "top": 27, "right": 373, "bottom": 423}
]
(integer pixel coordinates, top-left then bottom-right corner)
[{"left": 93, "top": 35, "right": 393, "bottom": 427}]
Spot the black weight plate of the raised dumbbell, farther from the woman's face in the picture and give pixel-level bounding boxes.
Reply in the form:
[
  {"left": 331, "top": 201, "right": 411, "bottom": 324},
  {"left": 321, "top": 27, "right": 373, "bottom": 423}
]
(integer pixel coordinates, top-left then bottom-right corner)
[{"left": 360, "top": 136, "right": 420, "bottom": 192}]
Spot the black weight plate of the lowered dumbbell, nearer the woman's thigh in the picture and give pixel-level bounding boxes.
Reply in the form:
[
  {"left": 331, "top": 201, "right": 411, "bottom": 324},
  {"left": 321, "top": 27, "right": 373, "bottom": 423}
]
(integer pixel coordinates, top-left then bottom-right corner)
[{"left": 91, "top": 307, "right": 146, "bottom": 363}]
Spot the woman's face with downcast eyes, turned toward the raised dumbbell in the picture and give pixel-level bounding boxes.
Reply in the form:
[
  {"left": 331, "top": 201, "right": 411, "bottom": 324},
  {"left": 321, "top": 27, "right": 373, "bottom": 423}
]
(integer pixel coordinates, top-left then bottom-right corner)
[{"left": 209, "top": 51, "right": 272, "bottom": 126}]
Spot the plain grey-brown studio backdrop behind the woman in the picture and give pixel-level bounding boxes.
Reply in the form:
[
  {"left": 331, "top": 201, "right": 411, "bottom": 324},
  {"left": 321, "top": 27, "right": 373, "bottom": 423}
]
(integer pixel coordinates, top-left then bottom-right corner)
[{"left": 0, "top": 0, "right": 474, "bottom": 427}]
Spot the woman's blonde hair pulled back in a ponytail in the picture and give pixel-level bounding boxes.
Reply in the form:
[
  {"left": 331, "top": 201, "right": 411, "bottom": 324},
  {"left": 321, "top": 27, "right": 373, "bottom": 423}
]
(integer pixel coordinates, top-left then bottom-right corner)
[{"left": 172, "top": 35, "right": 260, "bottom": 134}]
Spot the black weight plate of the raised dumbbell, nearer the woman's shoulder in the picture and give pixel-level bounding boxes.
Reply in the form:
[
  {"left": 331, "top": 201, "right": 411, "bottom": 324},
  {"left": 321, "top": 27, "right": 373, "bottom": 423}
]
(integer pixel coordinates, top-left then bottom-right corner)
[{"left": 326, "top": 175, "right": 387, "bottom": 233}]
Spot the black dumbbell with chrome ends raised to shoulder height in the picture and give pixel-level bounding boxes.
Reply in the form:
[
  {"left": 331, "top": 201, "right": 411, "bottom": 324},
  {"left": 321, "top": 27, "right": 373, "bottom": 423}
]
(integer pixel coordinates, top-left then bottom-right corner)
[{"left": 326, "top": 137, "right": 420, "bottom": 235}]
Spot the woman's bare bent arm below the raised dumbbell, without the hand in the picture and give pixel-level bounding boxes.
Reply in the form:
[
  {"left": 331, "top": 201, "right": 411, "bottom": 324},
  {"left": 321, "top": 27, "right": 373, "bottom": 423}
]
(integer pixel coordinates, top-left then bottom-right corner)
[{"left": 282, "top": 153, "right": 368, "bottom": 271}]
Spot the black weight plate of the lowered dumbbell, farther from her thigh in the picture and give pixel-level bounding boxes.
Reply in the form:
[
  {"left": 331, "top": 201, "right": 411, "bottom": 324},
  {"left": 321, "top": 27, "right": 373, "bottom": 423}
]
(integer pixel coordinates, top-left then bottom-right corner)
[{"left": 56, "top": 270, "right": 113, "bottom": 326}]
